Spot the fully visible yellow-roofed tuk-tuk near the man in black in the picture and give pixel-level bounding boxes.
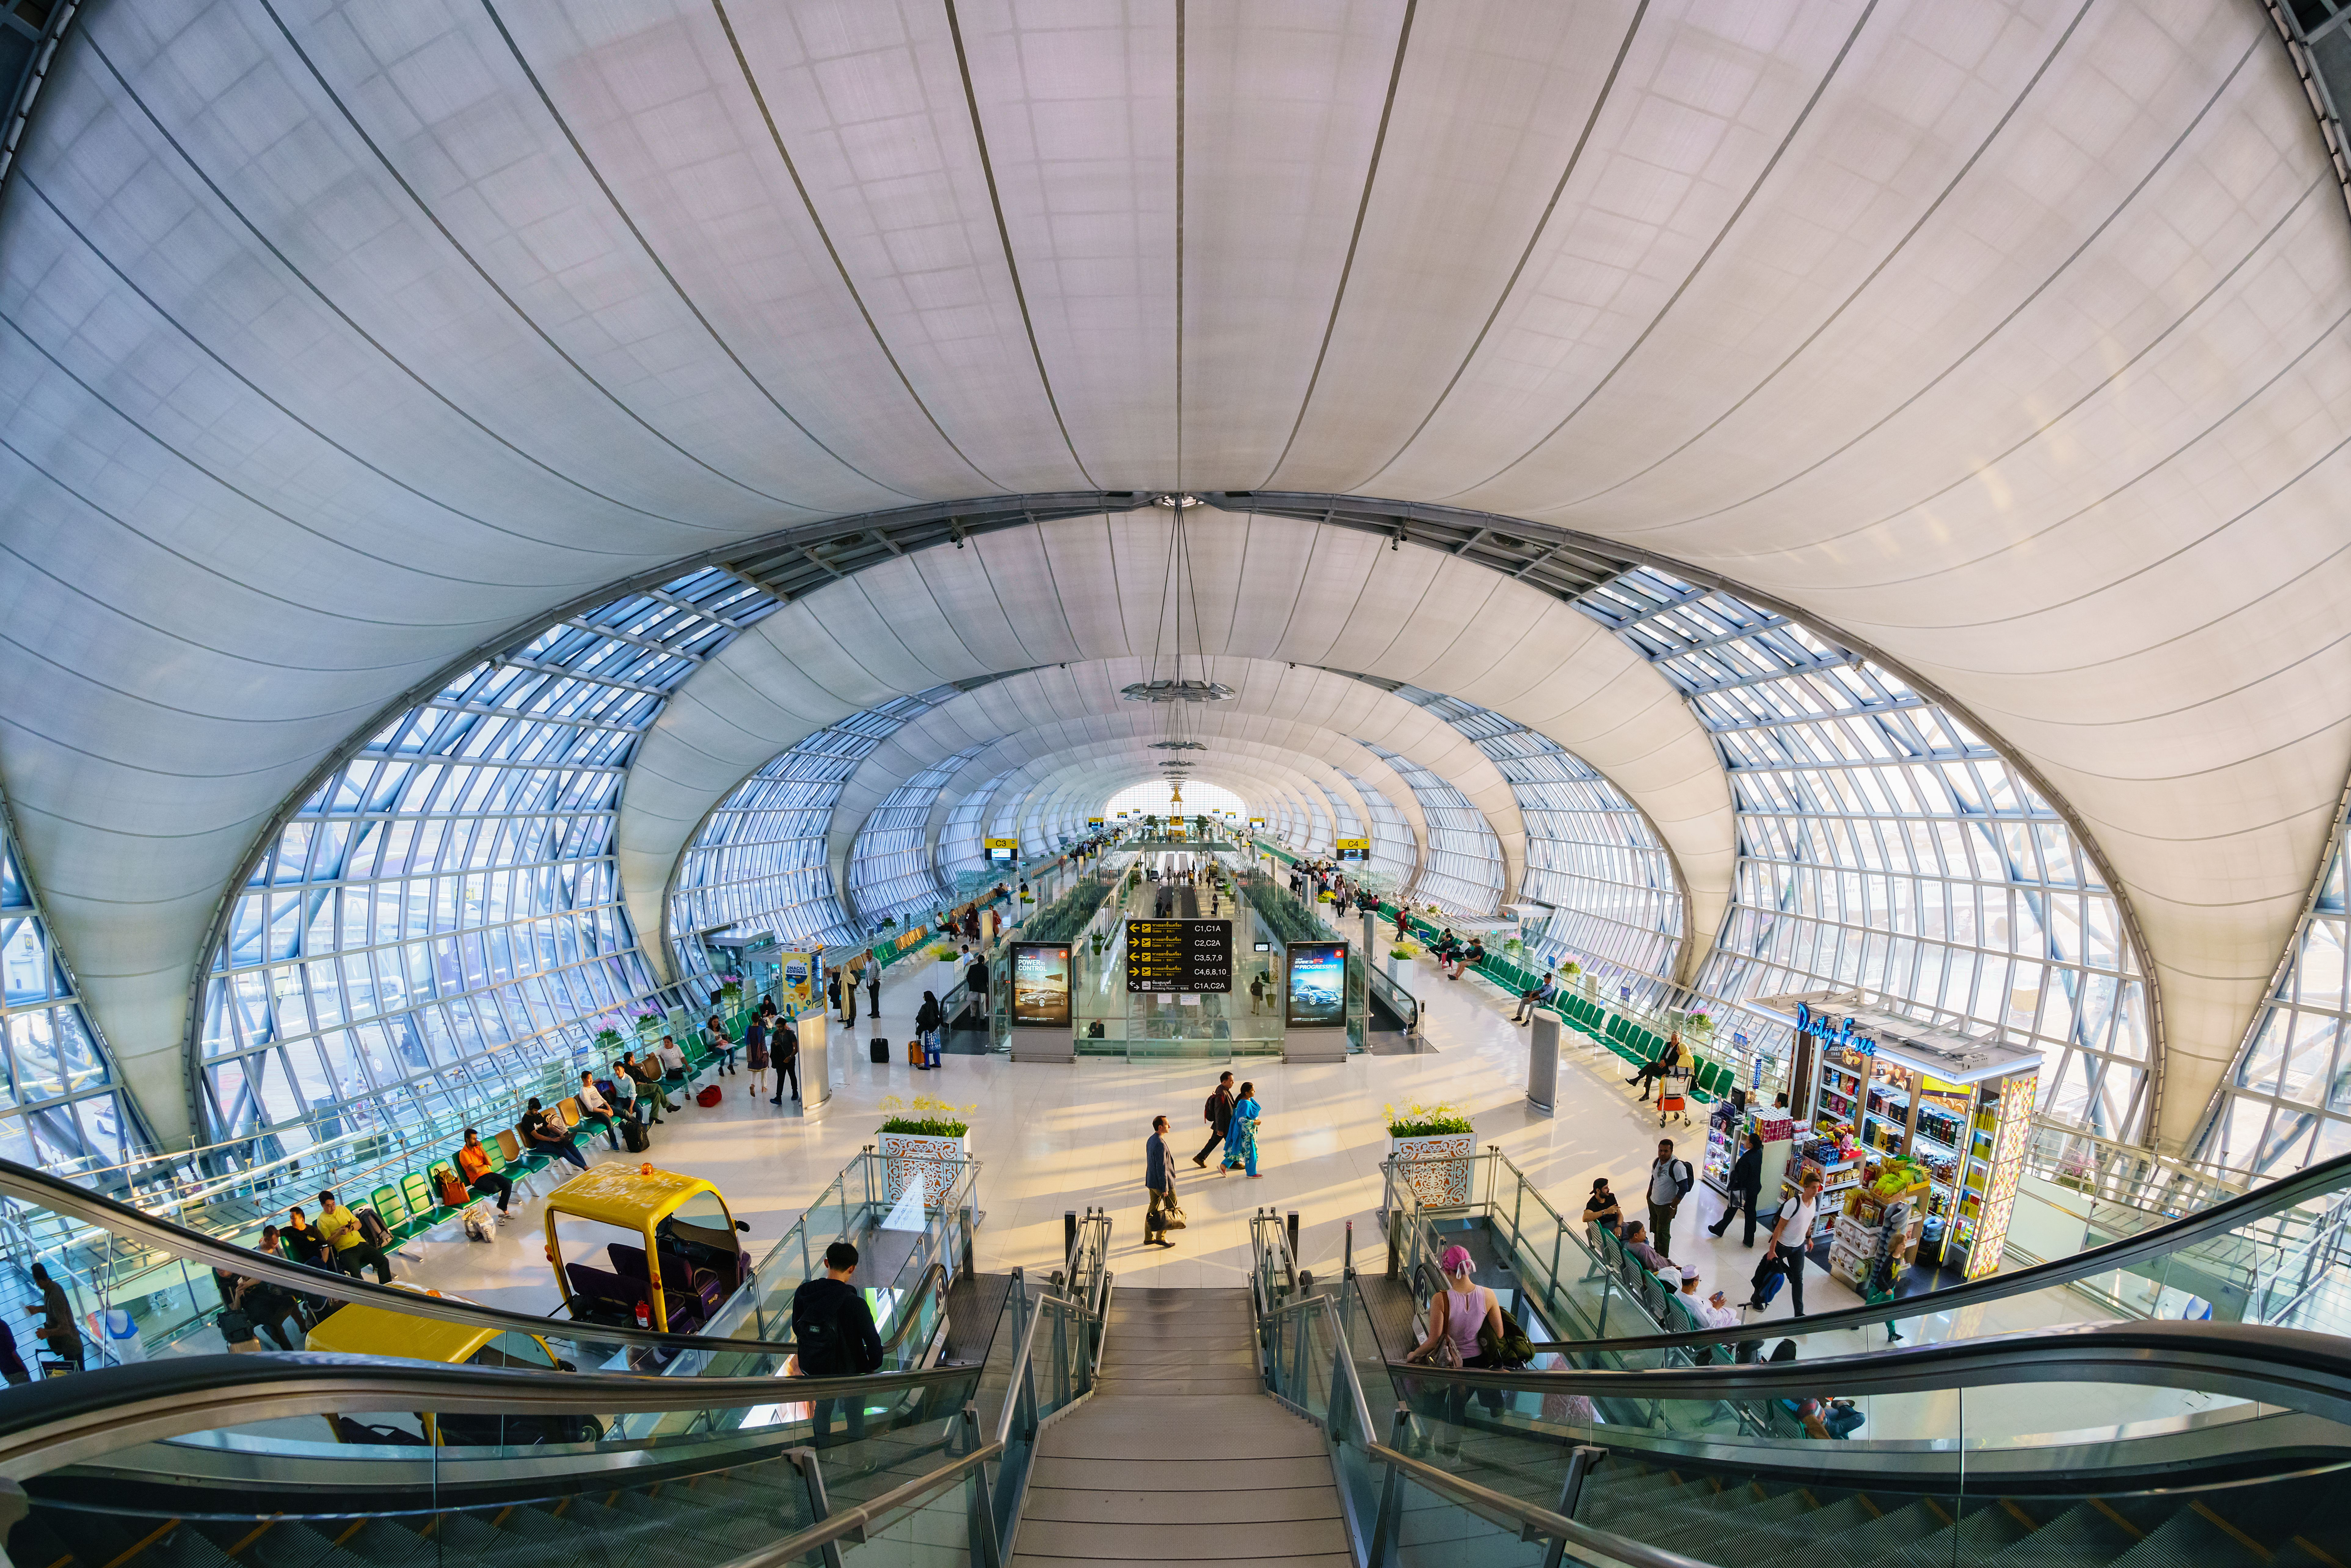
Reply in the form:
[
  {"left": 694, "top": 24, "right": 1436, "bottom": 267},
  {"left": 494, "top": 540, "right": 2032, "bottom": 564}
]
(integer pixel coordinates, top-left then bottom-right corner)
[{"left": 548, "top": 1161, "right": 750, "bottom": 1333}]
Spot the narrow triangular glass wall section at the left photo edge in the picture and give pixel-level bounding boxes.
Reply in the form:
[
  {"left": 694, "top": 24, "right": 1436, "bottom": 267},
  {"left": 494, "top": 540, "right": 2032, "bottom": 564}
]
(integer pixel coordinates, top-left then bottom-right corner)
[{"left": 0, "top": 799, "right": 151, "bottom": 1190}]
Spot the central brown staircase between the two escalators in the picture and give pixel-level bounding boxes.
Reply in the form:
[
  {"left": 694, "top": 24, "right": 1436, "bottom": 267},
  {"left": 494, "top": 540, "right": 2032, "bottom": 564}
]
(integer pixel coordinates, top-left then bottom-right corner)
[{"left": 1013, "top": 1286, "right": 1354, "bottom": 1568}]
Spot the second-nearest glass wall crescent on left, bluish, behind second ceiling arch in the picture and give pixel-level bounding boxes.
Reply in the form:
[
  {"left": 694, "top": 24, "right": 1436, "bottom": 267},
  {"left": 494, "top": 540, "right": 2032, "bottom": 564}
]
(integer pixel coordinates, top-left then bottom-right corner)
[{"left": 670, "top": 686, "right": 957, "bottom": 971}]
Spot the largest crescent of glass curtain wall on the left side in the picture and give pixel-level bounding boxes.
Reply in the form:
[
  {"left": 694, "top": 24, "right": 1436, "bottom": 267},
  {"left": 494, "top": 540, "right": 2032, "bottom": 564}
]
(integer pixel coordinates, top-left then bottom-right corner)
[{"left": 200, "top": 569, "right": 776, "bottom": 1157}]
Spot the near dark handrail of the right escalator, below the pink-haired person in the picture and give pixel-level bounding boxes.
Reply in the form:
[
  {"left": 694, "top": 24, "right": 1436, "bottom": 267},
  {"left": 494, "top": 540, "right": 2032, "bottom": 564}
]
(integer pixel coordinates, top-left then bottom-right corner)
[{"left": 1387, "top": 1323, "right": 2351, "bottom": 1427}]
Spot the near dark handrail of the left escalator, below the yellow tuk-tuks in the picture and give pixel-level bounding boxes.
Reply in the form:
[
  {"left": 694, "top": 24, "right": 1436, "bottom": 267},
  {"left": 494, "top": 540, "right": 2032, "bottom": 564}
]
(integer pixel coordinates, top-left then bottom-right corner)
[{"left": 0, "top": 1349, "right": 980, "bottom": 1481}]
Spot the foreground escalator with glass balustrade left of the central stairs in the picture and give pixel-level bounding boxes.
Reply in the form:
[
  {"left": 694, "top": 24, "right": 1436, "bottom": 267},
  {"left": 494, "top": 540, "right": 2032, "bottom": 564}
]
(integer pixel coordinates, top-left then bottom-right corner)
[{"left": 0, "top": 1220, "right": 1110, "bottom": 1568}]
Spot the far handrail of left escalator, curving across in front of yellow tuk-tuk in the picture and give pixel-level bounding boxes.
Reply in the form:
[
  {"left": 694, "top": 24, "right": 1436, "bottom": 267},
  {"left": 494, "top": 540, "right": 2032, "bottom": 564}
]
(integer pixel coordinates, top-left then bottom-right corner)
[{"left": 0, "top": 1159, "right": 795, "bottom": 1356}]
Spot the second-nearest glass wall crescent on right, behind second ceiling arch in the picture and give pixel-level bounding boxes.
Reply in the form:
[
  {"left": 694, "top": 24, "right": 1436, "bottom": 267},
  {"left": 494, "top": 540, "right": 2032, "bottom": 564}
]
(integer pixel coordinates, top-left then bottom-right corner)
[{"left": 1396, "top": 686, "right": 1688, "bottom": 1006}]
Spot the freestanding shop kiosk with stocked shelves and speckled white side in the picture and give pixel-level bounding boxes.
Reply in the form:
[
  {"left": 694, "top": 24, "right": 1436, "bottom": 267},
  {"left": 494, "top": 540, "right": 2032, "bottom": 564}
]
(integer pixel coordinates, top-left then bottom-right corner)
[{"left": 1761, "top": 992, "right": 2041, "bottom": 1279}]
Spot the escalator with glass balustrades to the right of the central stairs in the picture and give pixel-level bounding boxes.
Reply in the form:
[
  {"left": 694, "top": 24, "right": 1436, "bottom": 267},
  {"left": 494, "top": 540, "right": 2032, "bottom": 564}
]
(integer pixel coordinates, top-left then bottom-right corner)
[{"left": 1258, "top": 1161, "right": 2351, "bottom": 1568}]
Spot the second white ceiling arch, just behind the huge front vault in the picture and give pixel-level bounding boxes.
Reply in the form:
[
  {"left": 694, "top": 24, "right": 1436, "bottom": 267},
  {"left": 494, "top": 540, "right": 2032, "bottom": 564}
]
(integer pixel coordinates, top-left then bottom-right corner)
[{"left": 621, "top": 508, "right": 1733, "bottom": 931}]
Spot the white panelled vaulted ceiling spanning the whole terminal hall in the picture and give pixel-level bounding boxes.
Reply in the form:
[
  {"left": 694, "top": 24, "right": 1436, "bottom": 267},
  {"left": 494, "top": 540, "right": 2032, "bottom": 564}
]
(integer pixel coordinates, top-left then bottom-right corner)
[{"left": 0, "top": 0, "right": 2351, "bottom": 1138}]
